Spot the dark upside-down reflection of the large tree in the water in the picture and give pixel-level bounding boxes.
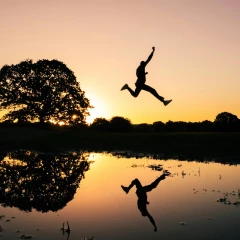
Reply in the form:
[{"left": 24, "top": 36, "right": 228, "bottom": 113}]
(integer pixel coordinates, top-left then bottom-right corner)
[{"left": 0, "top": 150, "right": 91, "bottom": 212}]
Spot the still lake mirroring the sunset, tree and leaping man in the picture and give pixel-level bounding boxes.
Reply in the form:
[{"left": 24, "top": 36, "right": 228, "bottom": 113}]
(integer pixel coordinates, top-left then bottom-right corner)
[{"left": 0, "top": 150, "right": 240, "bottom": 240}]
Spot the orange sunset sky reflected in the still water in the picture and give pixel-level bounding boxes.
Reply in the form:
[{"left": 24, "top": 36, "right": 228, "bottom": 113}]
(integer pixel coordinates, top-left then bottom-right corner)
[{"left": 0, "top": 154, "right": 240, "bottom": 240}]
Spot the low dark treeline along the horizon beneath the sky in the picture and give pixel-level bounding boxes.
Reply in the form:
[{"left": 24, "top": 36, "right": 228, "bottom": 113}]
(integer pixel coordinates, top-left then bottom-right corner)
[{"left": 0, "top": 112, "right": 240, "bottom": 132}]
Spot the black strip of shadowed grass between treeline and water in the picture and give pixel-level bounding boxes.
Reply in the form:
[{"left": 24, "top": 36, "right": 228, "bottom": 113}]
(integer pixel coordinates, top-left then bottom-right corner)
[{"left": 0, "top": 127, "right": 240, "bottom": 162}]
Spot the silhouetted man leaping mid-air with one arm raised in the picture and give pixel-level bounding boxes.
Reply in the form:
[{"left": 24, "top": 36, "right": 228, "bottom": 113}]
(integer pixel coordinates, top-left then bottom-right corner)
[{"left": 121, "top": 47, "right": 172, "bottom": 106}]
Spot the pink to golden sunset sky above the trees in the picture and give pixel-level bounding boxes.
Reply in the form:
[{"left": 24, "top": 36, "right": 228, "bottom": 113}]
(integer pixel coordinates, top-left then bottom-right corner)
[{"left": 0, "top": 0, "right": 240, "bottom": 123}]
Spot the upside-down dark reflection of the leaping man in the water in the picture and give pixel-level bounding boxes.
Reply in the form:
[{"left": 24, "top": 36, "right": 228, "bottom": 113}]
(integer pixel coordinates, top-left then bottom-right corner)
[{"left": 121, "top": 171, "right": 170, "bottom": 232}]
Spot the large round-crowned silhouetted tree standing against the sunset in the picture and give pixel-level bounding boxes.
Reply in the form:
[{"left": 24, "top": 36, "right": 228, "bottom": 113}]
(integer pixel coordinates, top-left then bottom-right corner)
[{"left": 0, "top": 59, "right": 91, "bottom": 124}]
